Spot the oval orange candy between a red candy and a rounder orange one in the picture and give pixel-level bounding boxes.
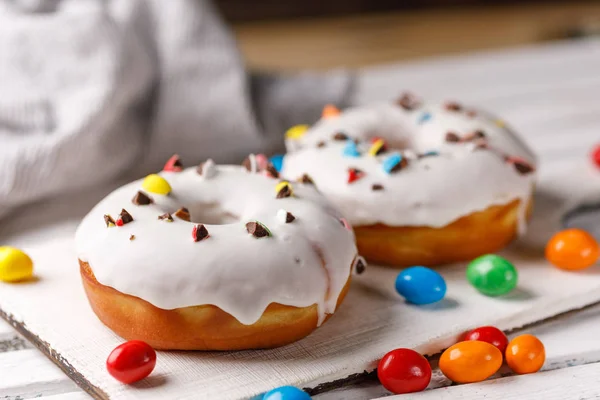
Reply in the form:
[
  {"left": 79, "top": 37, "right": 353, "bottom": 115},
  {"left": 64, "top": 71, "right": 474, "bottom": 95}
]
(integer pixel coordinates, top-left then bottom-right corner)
[{"left": 439, "top": 341, "right": 502, "bottom": 383}]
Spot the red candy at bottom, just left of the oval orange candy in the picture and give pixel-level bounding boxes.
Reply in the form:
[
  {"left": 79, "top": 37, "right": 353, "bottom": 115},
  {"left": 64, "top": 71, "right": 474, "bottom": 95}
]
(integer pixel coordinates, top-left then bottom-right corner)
[{"left": 377, "top": 349, "right": 431, "bottom": 394}]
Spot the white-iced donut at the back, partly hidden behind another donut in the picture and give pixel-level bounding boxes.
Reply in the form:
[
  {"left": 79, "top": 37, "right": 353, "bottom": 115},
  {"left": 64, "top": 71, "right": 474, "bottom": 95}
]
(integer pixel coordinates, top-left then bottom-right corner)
[{"left": 281, "top": 94, "right": 535, "bottom": 267}]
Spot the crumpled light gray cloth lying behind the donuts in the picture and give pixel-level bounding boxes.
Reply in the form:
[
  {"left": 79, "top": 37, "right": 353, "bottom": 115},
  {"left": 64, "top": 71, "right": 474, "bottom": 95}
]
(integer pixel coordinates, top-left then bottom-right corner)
[{"left": 0, "top": 0, "right": 352, "bottom": 215}]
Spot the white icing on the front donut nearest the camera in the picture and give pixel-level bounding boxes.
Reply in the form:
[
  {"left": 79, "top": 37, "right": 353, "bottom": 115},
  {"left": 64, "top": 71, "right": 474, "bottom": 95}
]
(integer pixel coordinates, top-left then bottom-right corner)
[{"left": 76, "top": 165, "right": 356, "bottom": 324}]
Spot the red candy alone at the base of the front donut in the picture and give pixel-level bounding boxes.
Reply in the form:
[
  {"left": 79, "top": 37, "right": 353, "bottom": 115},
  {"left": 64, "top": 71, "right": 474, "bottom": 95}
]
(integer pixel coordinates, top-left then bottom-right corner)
[{"left": 106, "top": 340, "right": 156, "bottom": 384}]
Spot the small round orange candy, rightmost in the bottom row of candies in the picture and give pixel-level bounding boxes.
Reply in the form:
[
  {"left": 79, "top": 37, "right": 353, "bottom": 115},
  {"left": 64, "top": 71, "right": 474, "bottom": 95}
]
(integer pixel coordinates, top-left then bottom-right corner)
[{"left": 505, "top": 334, "right": 546, "bottom": 374}]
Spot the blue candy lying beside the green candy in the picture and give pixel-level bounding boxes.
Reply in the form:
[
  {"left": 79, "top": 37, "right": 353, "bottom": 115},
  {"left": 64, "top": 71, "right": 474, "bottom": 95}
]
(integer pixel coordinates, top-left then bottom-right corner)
[{"left": 396, "top": 266, "right": 446, "bottom": 304}]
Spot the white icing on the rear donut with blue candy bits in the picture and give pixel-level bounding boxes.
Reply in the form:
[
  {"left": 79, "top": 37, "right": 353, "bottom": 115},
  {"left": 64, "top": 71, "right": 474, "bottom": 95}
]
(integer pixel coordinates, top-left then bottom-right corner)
[{"left": 282, "top": 104, "right": 535, "bottom": 233}]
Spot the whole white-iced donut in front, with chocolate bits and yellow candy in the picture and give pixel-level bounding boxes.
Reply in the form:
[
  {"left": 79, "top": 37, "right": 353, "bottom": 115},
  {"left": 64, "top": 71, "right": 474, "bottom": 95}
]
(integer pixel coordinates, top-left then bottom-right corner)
[{"left": 76, "top": 156, "right": 364, "bottom": 350}]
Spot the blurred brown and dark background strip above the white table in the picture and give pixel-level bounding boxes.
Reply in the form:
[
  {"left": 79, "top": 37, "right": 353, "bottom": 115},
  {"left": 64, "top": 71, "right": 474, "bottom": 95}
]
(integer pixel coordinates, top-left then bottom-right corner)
[{"left": 216, "top": 0, "right": 600, "bottom": 70}]
